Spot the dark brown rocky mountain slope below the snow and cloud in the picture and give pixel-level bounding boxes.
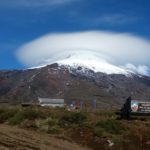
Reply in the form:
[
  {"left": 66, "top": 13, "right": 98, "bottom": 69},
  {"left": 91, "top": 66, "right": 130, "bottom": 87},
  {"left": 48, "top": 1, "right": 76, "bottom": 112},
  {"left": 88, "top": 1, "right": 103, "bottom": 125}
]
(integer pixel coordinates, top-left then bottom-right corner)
[{"left": 0, "top": 63, "right": 150, "bottom": 107}]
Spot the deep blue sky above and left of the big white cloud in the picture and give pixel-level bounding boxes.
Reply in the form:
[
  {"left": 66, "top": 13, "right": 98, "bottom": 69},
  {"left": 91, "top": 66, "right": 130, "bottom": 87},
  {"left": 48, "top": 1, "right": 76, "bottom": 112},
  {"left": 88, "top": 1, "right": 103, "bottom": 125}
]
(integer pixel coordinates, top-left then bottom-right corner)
[{"left": 0, "top": 0, "right": 150, "bottom": 69}]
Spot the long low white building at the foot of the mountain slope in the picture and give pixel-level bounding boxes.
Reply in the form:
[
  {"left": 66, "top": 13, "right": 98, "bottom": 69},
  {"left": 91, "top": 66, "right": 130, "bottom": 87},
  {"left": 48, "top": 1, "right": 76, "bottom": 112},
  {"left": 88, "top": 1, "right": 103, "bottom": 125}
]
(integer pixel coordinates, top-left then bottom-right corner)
[{"left": 38, "top": 97, "right": 64, "bottom": 107}]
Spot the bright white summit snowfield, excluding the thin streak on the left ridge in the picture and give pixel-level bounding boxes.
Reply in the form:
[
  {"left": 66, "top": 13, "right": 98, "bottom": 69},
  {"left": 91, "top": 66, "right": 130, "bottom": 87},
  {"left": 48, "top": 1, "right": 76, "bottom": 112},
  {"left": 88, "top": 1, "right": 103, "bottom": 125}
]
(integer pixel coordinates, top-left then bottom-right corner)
[{"left": 57, "top": 55, "right": 129, "bottom": 75}]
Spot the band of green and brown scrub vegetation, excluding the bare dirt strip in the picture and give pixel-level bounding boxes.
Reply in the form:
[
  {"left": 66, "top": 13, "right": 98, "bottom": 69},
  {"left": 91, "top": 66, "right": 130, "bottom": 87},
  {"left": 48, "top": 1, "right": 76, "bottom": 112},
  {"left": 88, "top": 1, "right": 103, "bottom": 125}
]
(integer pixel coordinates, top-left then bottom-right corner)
[{"left": 0, "top": 107, "right": 150, "bottom": 150}]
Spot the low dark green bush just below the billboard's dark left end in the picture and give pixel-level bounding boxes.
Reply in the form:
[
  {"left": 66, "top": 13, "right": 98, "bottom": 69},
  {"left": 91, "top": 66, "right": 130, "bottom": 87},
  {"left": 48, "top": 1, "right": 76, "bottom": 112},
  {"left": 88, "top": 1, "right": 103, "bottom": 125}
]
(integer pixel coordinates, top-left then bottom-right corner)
[{"left": 96, "top": 119, "right": 125, "bottom": 134}]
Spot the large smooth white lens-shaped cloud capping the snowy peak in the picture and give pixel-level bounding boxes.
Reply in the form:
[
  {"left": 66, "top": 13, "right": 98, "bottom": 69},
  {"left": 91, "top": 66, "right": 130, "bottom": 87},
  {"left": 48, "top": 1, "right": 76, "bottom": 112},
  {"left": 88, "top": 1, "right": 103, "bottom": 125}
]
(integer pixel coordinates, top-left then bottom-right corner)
[{"left": 17, "top": 31, "right": 150, "bottom": 75}]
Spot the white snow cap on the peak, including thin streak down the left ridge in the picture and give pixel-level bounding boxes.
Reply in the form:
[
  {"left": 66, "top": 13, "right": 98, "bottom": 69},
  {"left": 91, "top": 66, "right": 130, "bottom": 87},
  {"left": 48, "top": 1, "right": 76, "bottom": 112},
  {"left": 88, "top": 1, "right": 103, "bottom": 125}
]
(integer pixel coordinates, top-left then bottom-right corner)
[{"left": 30, "top": 52, "right": 133, "bottom": 76}]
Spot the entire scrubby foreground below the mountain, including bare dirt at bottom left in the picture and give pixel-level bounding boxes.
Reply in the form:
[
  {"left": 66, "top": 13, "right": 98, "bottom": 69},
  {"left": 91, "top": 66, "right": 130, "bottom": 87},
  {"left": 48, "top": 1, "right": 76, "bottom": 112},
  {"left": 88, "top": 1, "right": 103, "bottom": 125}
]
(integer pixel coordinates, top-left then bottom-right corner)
[{"left": 0, "top": 107, "right": 150, "bottom": 150}]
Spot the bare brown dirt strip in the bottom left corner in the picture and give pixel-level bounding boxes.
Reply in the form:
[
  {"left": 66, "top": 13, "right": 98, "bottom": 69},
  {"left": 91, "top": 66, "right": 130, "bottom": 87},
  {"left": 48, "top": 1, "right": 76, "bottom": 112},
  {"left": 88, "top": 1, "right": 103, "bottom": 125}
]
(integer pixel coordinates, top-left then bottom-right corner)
[{"left": 0, "top": 124, "right": 87, "bottom": 150}]
